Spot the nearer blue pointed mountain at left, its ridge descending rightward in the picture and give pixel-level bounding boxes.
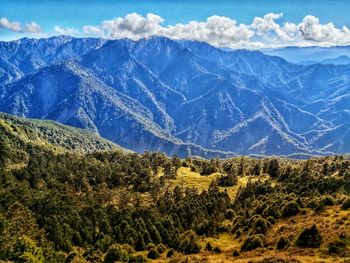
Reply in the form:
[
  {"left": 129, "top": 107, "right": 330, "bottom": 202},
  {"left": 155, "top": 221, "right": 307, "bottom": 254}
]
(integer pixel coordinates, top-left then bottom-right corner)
[{"left": 0, "top": 62, "right": 233, "bottom": 157}]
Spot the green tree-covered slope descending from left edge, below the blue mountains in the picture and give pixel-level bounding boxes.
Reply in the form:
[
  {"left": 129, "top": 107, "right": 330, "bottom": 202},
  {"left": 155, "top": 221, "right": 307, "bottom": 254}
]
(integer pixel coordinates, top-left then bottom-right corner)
[{"left": 0, "top": 113, "right": 123, "bottom": 153}]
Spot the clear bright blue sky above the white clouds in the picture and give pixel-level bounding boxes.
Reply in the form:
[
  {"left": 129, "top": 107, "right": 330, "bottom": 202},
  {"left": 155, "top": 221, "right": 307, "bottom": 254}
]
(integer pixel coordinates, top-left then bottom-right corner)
[{"left": 0, "top": 0, "right": 350, "bottom": 47}]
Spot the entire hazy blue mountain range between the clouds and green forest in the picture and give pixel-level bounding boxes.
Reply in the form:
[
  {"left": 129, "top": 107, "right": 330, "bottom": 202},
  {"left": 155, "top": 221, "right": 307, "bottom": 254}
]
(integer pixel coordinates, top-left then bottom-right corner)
[{"left": 0, "top": 36, "right": 350, "bottom": 157}]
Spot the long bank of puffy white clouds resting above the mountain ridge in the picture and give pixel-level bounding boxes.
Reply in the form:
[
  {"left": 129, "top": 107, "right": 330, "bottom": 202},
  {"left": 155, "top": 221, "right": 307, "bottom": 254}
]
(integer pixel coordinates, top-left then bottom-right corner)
[{"left": 55, "top": 13, "right": 350, "bottom": 48}]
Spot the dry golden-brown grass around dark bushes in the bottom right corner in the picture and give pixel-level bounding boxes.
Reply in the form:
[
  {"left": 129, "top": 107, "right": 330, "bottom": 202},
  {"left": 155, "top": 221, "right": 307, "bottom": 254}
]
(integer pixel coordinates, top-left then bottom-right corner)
[{"left": 147, "top": 206, "right": 350, "bottom": 263}]
